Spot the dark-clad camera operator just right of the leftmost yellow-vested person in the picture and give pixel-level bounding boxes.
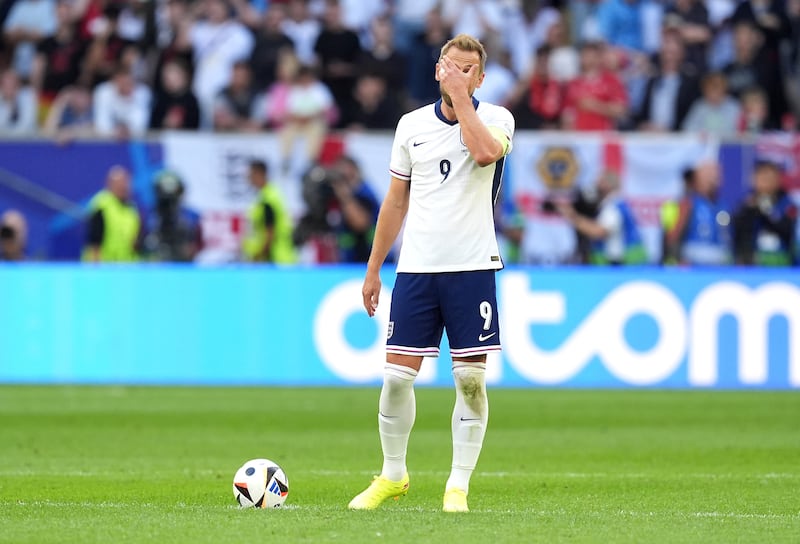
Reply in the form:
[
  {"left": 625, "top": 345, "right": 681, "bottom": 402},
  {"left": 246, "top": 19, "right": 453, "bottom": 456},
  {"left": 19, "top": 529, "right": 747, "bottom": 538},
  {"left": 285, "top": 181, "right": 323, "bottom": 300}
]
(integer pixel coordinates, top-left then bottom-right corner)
[{"left": 144, "top": 170, "right": 203, "bottom": 262}]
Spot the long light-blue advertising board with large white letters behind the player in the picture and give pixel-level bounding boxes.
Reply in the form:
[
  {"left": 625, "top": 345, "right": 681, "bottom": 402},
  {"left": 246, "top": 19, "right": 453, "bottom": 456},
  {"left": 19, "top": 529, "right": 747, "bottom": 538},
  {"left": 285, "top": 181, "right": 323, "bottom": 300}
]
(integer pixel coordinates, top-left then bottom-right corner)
[{"left": 0, "top": 265, "right": 800, "bottom": 389}]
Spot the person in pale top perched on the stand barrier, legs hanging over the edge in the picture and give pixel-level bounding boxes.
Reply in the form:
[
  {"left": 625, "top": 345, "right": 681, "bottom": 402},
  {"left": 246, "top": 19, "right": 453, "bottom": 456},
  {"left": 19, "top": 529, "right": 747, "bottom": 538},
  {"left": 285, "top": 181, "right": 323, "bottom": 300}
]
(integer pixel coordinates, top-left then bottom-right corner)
[{"left": 279, "top": 66, "right": 336, "bottom": 171}]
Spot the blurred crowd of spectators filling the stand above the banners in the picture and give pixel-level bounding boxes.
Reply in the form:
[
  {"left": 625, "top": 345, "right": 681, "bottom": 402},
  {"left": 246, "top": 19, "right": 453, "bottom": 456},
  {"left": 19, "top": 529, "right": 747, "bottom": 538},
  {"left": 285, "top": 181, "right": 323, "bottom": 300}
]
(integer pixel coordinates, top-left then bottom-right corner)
[{"left": 0, "top": 0, "right": 800, "bottom": 138}]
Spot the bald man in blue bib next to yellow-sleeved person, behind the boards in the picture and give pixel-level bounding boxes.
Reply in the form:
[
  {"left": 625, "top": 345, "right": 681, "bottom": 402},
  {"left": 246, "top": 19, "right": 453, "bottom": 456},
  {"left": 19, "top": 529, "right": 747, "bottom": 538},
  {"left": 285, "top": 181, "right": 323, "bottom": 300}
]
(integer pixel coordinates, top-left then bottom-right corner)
[{"left": 661, "top": 161, "right": 730, "bottom": 265}]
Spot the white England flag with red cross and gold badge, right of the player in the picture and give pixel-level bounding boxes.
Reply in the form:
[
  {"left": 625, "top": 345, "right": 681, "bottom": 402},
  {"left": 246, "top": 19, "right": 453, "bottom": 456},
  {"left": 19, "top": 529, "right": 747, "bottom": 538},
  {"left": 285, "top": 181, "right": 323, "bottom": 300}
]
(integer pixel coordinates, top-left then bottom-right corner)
[{"left": 503, "top": 132, "right": 720, "bottom": 263}]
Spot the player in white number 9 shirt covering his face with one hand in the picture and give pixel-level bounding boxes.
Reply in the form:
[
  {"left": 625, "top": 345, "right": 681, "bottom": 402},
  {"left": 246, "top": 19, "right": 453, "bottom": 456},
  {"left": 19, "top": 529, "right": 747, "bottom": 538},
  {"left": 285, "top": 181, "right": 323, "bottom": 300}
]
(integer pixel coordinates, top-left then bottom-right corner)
[{"left": 349, "top": 34, "right": 514, "bottom": 512}]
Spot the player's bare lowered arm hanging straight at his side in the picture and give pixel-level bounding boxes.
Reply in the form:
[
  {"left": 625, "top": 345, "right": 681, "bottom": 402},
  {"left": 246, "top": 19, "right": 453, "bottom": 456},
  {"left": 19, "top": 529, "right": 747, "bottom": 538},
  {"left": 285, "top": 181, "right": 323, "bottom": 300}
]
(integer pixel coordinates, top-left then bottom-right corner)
[{"left": 361, "top": 176, "right": 410, "bottom": 317}]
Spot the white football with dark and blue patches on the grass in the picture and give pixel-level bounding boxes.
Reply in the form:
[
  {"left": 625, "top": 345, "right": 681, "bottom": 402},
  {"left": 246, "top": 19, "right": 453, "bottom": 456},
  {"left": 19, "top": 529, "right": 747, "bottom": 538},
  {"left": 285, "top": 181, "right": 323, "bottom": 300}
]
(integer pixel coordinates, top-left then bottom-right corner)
[{"left": 233, "top": 459, "right": 289, "bottom": 508}]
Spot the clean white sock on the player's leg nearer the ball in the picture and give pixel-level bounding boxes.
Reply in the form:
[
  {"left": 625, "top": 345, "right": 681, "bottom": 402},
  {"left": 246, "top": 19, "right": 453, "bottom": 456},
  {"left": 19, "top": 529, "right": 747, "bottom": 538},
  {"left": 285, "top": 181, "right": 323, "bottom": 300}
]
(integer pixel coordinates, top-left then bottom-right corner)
[{"left": 378, "top": 363, "right": 417, "bottom": 482}]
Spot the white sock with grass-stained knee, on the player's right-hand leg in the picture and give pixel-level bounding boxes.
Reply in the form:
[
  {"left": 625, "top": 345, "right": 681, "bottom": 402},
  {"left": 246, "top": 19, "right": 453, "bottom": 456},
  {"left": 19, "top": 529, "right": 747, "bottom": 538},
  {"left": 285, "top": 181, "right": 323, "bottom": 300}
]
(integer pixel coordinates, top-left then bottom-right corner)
[{"left": 445, "top": 361, "right": 489, "bottom": 492}]
